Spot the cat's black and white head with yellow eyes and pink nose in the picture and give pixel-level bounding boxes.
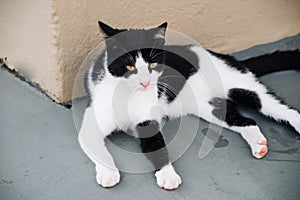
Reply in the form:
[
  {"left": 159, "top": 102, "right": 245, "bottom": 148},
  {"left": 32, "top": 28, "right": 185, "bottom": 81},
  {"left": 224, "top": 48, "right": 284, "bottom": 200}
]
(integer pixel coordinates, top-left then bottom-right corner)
[{"left": 98, "top": 21, "right": 167, "bottom": 89}]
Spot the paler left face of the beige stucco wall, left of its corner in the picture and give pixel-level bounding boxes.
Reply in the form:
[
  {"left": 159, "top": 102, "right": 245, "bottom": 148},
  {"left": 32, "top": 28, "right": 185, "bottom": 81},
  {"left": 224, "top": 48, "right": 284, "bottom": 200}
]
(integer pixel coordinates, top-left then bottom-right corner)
[{"left": 0, "top": 0, "right": 63, "bottom": 99}]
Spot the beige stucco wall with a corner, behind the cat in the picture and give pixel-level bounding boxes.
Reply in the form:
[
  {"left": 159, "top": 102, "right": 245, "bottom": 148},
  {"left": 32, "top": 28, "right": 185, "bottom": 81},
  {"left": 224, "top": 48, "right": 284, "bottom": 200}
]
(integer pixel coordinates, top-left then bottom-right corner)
[{"left": 0, "top": 0, "right": 300, "bottom": 102}]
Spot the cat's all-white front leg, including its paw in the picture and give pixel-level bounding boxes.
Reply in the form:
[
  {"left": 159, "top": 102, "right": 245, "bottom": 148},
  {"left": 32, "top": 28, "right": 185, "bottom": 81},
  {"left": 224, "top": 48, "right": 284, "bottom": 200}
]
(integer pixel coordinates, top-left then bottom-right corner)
[{"left": 78, "top": 107, "right": 120, "bottom": 187}]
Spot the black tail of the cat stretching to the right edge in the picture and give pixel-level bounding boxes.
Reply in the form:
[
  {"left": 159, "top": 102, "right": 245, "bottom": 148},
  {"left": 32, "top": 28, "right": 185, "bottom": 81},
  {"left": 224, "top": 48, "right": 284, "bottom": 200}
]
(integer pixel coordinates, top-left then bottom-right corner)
[{"left": 240, "top": 50, "right": 300, "bottom": 77}]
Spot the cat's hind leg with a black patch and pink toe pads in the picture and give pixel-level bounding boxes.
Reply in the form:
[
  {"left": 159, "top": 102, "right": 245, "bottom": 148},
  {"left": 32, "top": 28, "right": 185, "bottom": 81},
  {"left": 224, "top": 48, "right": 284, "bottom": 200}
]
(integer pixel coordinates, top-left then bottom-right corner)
[{"left": 188, "top": 97, "right": 268, "bottom": 158}]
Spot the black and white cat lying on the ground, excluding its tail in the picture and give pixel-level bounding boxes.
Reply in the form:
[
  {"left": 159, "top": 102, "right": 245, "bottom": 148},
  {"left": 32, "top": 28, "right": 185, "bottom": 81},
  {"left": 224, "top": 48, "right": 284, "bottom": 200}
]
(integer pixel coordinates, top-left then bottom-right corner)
[{"left": 78, "top": 22, "right": 300, "bottom": 190}]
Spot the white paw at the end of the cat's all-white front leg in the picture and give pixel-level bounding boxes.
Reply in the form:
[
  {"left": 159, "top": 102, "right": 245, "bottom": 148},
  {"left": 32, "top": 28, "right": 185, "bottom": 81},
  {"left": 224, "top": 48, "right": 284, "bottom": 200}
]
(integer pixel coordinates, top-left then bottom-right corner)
[{"left": 96, "top": 165, "right": 120, "bottom": 187}]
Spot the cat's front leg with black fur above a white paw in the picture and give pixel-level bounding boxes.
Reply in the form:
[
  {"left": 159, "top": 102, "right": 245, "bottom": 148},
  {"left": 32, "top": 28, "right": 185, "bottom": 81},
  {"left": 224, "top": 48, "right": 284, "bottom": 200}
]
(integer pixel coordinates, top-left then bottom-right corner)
[{"left": 136, "top": 120, "right": 181, "bottom": 190}]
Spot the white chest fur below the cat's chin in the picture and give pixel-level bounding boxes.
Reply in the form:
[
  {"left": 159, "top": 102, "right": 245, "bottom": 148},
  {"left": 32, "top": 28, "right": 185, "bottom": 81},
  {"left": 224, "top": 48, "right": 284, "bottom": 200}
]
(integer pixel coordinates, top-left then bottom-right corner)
[{"left": 92, "top": 77, "right": 163, "bottom": 133}]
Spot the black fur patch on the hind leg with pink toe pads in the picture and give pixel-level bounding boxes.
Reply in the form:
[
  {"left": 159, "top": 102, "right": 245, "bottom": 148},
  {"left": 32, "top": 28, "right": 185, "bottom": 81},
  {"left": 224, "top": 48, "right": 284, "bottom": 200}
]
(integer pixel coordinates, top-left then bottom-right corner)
[{"left": 209, "top": 98, "right": 256, "bottom": 126}]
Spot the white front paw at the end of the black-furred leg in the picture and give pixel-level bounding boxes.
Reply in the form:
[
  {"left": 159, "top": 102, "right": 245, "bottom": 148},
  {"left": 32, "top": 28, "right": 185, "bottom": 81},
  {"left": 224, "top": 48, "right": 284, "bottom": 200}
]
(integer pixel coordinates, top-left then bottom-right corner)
[{"left": 155, "top": 164, "right": 181, "bottom": 190}]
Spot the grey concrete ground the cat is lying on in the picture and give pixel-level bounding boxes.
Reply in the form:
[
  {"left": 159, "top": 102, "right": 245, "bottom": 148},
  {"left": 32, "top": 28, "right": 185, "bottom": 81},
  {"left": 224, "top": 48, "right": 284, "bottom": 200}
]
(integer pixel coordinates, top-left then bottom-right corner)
[{"left": 0, "top": 35, "right": 300, "bottom": 200}]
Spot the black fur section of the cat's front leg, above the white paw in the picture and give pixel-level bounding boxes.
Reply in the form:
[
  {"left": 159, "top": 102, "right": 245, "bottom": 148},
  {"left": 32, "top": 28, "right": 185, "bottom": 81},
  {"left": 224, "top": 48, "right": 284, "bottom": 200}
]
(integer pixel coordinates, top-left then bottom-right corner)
[{"left": 136, "top": 120, "right": 169, "bottom": 170}]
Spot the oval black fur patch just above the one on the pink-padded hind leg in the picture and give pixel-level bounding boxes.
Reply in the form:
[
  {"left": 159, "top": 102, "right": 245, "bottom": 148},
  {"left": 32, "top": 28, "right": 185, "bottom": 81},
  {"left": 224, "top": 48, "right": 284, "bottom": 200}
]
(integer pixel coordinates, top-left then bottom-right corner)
[{"left": 228, "top": 88, "right": 262, "bottom": 111}]
